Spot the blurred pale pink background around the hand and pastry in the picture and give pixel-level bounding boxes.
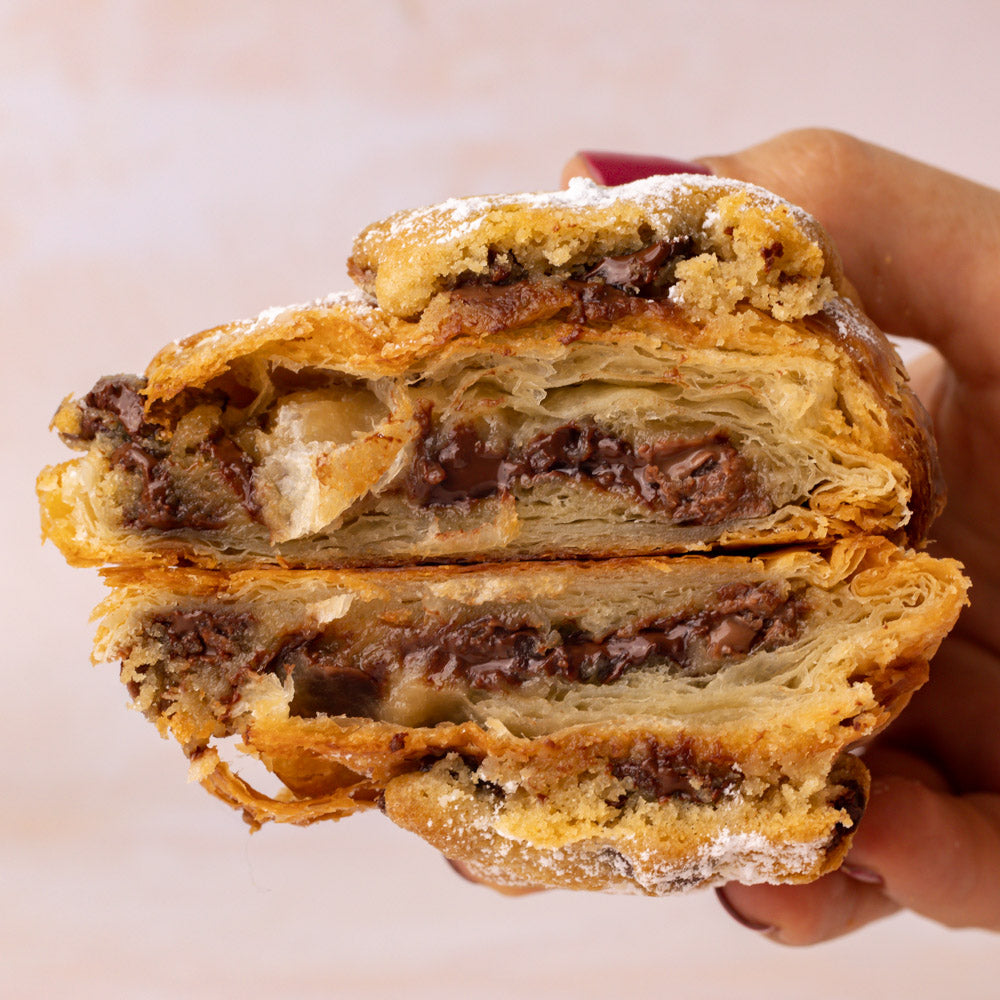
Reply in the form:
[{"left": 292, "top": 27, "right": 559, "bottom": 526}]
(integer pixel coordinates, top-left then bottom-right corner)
[{"left": 7, "top": 0, "right": 1000, "bottom": 1000}]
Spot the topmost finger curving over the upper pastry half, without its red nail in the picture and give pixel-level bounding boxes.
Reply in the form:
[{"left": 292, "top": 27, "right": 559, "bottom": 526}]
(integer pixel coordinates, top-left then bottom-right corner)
[{"left": 703, "top": 129, "right": 1000, "bottom": 385}]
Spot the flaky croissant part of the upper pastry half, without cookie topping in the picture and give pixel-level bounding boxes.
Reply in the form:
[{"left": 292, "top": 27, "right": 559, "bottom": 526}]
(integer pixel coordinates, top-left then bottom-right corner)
[{"left": 39, "top": 288, "right": 942, "bottom": 567}]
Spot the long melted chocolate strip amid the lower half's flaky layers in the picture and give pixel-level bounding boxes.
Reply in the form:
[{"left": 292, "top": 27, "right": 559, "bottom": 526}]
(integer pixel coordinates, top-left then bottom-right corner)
[{"left": 254, "top": 583, "right": 807, "bottom": 718}]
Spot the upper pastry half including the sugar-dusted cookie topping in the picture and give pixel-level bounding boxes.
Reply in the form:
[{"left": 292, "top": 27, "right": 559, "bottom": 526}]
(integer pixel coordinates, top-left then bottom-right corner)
[{"left": 39, "top": 178, "right": 942, "bottom": 568}]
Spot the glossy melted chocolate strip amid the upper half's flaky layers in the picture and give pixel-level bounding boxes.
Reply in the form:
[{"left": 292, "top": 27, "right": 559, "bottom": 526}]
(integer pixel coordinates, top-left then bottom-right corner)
[{"left": 405, "top": 407, "right": 774, "bottom": 525}]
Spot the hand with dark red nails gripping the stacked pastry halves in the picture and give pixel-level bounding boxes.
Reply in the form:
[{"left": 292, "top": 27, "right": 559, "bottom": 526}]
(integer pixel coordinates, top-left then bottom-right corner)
[{"left": 564, "top": 130, "right": 1000, "bottom": 944}]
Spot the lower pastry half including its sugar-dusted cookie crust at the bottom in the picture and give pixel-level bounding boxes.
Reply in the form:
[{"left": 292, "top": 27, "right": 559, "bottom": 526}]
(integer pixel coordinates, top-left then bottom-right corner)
[{"left": 96, "top": 538, "right": 965, "bottom": 893}]
